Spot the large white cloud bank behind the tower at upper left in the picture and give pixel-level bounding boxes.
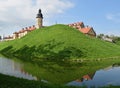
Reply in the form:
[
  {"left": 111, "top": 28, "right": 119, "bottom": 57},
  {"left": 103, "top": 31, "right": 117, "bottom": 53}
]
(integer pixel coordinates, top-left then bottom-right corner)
[{"left": 0, "top": 0, "right": 74, "bottom": 33}]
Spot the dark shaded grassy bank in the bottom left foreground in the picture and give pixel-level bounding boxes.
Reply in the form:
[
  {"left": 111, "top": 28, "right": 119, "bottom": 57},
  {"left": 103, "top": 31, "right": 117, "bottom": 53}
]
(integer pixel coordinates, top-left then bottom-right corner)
[{"left": 0, "top": 74, "right": 79, "bottom": 88}]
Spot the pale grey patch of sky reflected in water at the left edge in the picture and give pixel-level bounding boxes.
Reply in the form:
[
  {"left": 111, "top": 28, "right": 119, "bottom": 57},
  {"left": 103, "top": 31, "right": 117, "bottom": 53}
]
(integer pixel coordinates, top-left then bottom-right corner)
[{"left": 0, "top": 58, "right": 37, "bottom": 80}]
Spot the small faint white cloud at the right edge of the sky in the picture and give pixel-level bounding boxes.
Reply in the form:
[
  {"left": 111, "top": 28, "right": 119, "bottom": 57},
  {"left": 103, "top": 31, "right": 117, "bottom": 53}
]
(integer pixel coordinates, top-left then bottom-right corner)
[{"left": 106, "top": 13, "right": 120, "bottom": 23}]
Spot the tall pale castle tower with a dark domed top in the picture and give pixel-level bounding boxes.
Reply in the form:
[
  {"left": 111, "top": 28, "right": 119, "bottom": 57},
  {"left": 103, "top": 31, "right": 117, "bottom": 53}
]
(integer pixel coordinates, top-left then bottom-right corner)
[{"left": 36, "top": 9, "right": 43, "bottom": 29}]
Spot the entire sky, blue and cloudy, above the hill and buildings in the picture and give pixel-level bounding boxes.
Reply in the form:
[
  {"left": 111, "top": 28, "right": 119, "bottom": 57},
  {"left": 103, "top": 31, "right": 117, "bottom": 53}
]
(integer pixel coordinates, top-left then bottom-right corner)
[{"left": 0, "top": 0, "right": 120, "bottom": 36}]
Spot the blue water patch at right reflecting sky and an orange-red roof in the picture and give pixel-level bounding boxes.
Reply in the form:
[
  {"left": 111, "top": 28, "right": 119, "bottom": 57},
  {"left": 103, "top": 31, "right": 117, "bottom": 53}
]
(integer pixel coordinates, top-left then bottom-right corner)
[{"left": 67, "top": 66, "right": 120, "bottom": 87}]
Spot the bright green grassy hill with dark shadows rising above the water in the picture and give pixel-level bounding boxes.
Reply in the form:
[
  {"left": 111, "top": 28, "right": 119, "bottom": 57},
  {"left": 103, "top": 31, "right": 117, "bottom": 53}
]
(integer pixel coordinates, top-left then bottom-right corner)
[{"left": 0, "top": 24, "right": 120, "bottom": 59}]
